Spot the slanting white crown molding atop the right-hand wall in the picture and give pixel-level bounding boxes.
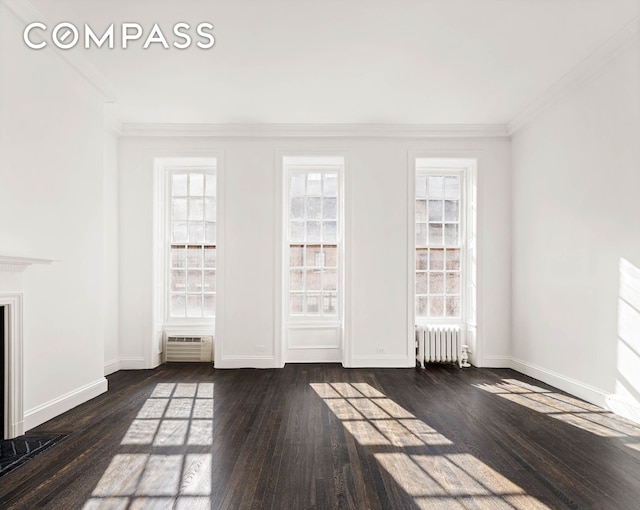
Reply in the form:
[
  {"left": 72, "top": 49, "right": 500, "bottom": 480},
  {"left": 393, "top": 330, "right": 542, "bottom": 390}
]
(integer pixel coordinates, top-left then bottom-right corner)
[{"left": 507, "top": 16, "right": 640, "bottom": 135}]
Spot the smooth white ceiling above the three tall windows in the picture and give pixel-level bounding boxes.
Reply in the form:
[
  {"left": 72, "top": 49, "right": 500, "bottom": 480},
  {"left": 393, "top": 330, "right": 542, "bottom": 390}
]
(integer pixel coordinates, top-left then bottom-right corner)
[{"left": 32, "top": 0, "right": 640, "bottom": 124}]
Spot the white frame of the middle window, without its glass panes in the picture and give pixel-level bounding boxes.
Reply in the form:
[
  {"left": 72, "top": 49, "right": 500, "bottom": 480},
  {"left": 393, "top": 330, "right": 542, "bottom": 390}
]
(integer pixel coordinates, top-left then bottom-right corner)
[{"left": 282, "top": 155, "right": 345, "bottom": 327}]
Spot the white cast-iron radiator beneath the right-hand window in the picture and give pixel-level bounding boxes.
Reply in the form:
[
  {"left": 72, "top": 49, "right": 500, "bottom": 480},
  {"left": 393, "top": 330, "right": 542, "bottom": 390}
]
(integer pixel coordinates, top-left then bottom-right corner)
[{"left": 416, "top": 326, "right": 468, "bottom": 368}]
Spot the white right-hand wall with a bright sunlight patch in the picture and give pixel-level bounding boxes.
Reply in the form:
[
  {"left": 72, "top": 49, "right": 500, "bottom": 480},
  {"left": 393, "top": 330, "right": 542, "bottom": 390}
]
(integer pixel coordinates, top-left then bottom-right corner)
[{"left": 512, "top": 43, "right": 640, "bottom": 419}]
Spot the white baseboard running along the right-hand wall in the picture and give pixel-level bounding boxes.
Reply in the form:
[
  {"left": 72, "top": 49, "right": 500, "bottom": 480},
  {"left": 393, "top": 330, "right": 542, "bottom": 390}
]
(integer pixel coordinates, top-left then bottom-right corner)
[{"left": 511, "top": 358, "right": 640, "bottom": 423}]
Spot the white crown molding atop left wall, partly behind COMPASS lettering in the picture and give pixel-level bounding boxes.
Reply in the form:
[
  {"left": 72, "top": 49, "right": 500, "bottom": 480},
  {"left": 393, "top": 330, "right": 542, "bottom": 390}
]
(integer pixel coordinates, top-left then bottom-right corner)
[{"left": 2, "top": 0, "right": 116, "bottom": 102}]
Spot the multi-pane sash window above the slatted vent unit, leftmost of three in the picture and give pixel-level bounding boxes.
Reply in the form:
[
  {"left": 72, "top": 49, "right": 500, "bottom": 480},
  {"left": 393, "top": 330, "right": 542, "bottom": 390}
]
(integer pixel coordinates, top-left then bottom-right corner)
[{"left": 168, "top": 169, "right": 217, "bottom": 319}]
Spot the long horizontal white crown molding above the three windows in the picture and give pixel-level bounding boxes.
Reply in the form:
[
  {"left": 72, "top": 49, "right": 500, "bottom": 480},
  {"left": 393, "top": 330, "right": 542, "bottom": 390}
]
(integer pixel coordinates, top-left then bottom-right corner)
[{"left": 122, "top": 123, "right": 509, "bottom": 138}]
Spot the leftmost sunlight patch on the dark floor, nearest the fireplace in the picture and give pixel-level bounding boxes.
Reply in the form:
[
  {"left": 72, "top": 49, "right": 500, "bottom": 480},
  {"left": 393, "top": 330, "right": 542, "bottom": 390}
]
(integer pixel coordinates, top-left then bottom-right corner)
[{"left": 83, "top": 383, "right": 214, "bottom": 510}]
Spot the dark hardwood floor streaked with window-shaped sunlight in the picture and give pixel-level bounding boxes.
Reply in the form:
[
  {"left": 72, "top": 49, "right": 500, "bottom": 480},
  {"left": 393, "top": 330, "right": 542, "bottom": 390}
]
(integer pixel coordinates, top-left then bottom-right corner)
[{"left": 0, "top": 364, "right": 640, "bottom": 510}]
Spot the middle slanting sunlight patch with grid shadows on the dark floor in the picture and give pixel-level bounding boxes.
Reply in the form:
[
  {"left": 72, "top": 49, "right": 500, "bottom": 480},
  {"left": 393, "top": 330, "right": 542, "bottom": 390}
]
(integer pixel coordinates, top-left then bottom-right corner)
[{"left": 311, "top": 383, "right": 547, "bottom": 510}]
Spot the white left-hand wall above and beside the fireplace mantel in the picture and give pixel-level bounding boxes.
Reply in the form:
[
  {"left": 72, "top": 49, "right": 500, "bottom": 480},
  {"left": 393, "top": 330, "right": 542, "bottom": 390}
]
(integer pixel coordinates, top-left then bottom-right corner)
[{"left": 0, "top": 4, "right": 113, "bottom": 429}]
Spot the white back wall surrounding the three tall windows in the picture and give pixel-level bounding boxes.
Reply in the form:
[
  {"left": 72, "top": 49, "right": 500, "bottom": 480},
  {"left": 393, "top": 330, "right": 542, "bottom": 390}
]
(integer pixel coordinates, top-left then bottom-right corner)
[{"left": 119, "top": 133, "right": 511, "bottom": 368}]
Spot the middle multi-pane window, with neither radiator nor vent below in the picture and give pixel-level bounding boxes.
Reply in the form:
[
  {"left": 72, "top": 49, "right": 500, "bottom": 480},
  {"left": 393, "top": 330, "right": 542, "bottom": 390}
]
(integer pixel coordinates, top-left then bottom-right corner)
[{"left": 284, "top": 158, "right": 342, "bottom": 320}]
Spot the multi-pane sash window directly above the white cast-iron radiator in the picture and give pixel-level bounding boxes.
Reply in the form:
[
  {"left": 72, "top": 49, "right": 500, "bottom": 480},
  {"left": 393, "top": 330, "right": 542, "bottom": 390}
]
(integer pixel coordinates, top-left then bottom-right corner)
[{"left": 415, "top": 169, "right": 464, "bottom": 319}]
